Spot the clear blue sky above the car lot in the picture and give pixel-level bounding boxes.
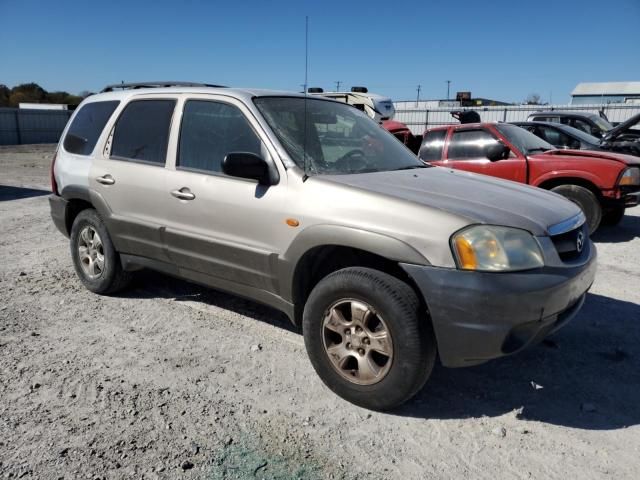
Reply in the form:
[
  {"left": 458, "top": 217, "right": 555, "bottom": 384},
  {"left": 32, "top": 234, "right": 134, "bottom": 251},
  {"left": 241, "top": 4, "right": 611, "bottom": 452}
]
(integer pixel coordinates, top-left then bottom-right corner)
[{"left": 0, "top": 0, "right": 640, "bottom": 103}]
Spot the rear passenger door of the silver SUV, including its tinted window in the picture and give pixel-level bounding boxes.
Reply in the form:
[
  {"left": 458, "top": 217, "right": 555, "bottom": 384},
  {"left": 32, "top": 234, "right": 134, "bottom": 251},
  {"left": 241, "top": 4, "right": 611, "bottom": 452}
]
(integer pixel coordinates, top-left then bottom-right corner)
[{"left": 89, "top": 97, "right": 176, "bottom": 261}]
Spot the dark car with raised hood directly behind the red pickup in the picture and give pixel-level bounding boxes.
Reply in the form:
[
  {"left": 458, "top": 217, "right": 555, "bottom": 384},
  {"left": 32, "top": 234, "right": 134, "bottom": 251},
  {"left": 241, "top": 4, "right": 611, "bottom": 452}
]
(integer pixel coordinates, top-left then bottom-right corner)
[{"left": 511, "top": 114, "right": 640, "bottom": 156}]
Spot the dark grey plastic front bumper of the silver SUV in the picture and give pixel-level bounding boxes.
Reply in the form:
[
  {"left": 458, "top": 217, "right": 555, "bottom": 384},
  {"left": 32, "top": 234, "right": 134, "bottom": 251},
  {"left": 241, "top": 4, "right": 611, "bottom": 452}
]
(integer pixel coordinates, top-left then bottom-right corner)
[{"left": 401, "top": 245, "right": 596, "bottom": 367}]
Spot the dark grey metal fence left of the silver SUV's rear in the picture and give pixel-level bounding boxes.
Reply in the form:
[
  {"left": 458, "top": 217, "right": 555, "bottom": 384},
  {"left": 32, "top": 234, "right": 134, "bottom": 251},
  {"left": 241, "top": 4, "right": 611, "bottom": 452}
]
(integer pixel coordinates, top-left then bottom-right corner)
[{"left": 0, "top": 108, "right": 73, "bottom": 145}]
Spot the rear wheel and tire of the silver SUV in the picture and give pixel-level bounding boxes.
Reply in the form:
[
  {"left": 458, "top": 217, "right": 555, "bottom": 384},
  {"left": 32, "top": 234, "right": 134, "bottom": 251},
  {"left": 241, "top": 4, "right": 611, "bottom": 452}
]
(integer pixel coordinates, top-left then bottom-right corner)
[{"left": 70, "top": 209, "right": 131, "bottom": 294}]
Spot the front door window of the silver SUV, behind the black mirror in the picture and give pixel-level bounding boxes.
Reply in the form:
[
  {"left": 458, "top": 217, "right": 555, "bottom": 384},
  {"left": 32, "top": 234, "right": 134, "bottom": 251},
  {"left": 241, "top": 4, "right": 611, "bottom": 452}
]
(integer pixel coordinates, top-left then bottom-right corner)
[{"left": 177, "top": 100, "right": 262, "bottom": 172}]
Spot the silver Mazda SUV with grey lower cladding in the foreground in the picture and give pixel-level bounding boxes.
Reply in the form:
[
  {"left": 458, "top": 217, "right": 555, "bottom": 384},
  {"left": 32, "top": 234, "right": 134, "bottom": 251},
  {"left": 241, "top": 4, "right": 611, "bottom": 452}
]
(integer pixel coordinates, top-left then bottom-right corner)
[{"left": 50, "top": 82, "right": 596, "bottom": 409}]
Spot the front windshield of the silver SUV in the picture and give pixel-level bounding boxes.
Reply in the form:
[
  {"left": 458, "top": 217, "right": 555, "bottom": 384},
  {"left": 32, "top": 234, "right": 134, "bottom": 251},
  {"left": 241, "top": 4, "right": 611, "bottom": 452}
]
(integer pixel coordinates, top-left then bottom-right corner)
[{"left": 254, "top": 97, "right": 427, "bottom": 174}]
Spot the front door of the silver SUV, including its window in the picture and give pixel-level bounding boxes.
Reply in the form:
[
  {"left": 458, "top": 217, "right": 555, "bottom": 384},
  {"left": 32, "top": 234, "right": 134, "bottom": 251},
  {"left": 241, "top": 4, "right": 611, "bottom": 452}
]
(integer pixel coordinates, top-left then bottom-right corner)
[{"left": 164, "top": 99, "right": 286, "bottom": 292}]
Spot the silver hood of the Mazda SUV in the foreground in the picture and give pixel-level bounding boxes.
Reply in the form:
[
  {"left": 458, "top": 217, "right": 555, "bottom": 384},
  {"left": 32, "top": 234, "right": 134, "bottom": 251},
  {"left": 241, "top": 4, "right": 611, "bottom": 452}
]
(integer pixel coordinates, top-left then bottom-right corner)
[{"left": 323, "top": 167, "right": 580, "bottom": 236}]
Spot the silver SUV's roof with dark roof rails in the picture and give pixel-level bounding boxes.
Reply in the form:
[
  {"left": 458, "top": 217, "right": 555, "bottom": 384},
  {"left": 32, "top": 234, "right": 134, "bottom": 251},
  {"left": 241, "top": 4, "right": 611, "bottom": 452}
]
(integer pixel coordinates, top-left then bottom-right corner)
[{"left": 86, "top": 86, "right": 334, "bottom": 102}]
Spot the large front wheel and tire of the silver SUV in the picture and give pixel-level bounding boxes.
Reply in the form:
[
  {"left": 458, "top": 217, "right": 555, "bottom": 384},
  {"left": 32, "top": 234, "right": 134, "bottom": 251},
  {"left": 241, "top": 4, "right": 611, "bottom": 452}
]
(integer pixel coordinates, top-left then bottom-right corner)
[{"left": 302, "top": 267, "right": 436, "bottom": 410}]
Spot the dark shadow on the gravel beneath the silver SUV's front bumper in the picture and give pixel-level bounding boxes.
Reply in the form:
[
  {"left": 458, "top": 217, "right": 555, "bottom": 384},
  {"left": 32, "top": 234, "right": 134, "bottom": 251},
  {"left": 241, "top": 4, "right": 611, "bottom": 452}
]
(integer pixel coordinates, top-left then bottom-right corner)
[{"left": 392, "top": 294, "right": 640, "bottom": 430}]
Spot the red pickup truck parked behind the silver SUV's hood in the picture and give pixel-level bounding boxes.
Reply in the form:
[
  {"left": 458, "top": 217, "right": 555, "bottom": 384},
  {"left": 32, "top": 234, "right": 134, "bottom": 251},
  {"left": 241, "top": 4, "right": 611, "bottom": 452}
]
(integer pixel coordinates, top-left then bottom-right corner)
[{"left": 418, "top": 123, "right": 640, "bottom": 233}]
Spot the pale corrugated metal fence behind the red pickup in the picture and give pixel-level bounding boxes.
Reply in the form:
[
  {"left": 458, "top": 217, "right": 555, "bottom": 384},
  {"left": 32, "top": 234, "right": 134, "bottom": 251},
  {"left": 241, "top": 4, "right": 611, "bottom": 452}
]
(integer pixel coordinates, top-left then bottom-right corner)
[{"left": 394, "top": 101, "right": 640, "bottom": 135}]
